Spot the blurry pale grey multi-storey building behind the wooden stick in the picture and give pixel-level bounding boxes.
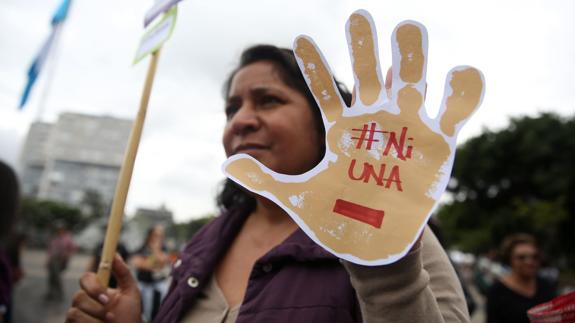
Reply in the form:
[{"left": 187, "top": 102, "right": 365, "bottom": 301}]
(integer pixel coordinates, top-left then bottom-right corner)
[{"left": 20, "top": 113, "right": 132, "bottom": 209}]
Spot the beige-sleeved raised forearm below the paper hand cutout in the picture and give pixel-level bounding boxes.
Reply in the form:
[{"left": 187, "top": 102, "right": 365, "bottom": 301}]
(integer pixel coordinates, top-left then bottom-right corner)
[{"left": 344, "top": 228, "right": 469, "bottom": 323}]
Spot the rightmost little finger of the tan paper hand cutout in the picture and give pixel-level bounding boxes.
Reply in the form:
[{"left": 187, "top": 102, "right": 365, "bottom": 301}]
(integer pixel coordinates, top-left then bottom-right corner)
[{"left": 439, "top": 66, "right": 485, "bottom": 137}]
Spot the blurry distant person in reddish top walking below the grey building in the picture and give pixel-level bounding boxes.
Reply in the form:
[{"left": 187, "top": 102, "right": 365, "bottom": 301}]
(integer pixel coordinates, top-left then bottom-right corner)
[{"left": 44, "top": 223, "right": 76, "bottom": 302}]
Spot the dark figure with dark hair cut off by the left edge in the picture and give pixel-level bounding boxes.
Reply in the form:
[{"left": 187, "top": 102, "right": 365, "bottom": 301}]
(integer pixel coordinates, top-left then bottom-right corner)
[{"left": 0, "top": 161, "right": 20, "bottom": 323}]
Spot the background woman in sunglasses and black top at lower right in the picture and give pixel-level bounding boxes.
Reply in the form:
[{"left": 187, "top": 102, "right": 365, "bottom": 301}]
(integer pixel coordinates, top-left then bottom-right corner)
[{"left": 487, "top": 233, "right": 556, "bottom": 323}]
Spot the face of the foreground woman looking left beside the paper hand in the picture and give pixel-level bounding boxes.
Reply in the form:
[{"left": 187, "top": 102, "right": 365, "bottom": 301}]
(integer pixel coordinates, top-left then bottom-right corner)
[{"left": 223, "top": 61, "right": 323, "bottom": 175}]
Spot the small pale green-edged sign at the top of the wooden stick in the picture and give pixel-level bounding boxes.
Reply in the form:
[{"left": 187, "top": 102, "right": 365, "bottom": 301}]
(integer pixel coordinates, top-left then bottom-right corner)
[{"left": 134, "top": 7, "right": 178, "bottom": 64}]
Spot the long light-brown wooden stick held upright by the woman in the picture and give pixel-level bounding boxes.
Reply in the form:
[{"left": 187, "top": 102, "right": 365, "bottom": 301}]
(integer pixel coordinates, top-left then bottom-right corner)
[{"left": 97, "top": 48, "right": 161, "bottom": 286}]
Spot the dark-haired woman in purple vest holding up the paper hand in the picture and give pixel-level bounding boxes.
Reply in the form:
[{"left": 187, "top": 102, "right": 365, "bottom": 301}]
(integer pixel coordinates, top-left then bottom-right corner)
[{"left": 68, "top": 45, "right": 469, "bottom": 322}]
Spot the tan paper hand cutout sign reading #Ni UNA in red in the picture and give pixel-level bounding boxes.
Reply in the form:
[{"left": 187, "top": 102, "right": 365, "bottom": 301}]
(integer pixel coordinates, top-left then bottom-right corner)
[{"left": 223, "top": 10, "right": 484, "bottom": 266}]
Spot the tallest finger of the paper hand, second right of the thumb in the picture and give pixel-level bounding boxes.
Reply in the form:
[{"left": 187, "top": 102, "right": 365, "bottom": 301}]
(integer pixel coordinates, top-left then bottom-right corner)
[{"left": 346, "top": 10, "right": 382, "bottom": 105}]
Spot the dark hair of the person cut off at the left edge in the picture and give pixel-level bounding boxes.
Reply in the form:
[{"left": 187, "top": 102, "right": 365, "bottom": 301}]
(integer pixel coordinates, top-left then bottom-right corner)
[{"left": 0, "top": 161, "right": 20, "bottom": 243}]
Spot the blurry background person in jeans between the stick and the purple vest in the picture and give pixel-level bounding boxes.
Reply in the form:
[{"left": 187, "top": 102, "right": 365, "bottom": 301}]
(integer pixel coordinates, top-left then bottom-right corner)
[{"left": 131, "top": 225, "right": 171, "bottom": 322}]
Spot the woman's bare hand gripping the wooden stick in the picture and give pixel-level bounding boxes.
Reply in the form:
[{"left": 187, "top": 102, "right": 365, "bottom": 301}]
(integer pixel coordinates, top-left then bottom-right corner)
[{"left": 66, "top": 254, "right": 142, "bottom": 323}]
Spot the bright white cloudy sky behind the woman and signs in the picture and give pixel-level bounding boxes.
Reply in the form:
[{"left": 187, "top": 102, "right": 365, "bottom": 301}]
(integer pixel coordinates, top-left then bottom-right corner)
[{"left": 0, "top": 0, "right": 575, "bottom": 221}]
